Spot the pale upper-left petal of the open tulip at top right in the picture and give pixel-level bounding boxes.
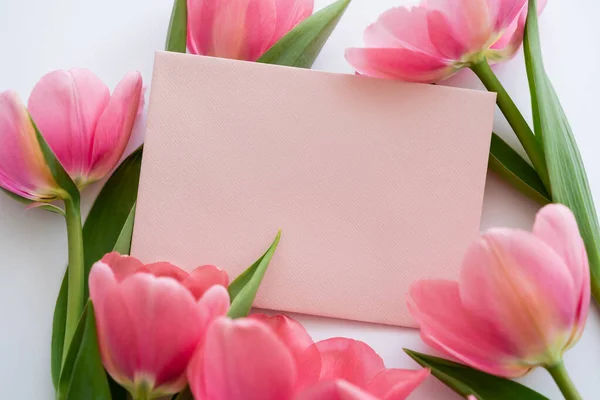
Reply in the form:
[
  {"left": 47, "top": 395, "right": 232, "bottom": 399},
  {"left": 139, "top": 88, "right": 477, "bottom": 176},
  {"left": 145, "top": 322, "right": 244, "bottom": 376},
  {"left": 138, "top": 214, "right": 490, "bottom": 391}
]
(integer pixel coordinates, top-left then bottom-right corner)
[{"left": 364, "top": 6, "right": 440, "bottom": 57}]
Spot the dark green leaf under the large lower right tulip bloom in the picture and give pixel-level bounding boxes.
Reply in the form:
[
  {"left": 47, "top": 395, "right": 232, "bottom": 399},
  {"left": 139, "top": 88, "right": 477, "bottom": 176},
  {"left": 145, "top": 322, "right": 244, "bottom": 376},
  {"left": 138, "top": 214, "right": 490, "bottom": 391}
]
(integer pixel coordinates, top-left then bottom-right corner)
[{"left": 404, "top": 349, "right": 547, "bottom": 400}]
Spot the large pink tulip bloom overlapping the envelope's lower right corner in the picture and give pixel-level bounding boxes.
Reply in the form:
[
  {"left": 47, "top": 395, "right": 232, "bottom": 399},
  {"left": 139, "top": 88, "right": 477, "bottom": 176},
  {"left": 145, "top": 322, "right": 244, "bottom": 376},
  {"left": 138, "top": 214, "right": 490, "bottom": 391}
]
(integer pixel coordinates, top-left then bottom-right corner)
[{"left": 408, "top": 205, "right": 590, "bottom": 377}]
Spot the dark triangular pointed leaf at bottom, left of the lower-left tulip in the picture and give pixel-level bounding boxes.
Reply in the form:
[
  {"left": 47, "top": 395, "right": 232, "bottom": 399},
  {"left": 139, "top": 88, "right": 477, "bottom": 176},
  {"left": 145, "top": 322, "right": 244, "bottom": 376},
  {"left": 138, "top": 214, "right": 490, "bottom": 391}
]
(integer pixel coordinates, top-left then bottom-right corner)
[{"left": 56, "top": 301, "right": 111, "bottom": 400}]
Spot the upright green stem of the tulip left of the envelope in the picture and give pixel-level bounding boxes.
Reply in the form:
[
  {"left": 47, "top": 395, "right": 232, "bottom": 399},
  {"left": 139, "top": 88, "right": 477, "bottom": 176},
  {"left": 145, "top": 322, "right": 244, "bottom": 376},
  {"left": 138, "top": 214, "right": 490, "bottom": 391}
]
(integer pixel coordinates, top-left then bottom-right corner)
[{"left": 63, "top": 199, "right": 84, "bottom": 362}]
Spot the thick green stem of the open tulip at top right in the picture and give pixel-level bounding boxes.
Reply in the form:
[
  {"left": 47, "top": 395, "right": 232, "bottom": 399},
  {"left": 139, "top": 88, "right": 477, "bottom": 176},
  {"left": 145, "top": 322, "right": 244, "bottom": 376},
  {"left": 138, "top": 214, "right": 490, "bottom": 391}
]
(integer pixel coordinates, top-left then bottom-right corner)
[{"left": 471, "top": 59, "right": 551, "bottom": 193}]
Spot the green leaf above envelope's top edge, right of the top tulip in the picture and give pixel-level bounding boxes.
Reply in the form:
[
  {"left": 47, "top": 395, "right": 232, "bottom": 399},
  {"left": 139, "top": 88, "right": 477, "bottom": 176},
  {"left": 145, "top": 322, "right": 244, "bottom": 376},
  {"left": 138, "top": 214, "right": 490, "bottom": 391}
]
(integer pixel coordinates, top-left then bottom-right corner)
[{"left": 258, "top": 0, "right": 350, "bottom": 68}]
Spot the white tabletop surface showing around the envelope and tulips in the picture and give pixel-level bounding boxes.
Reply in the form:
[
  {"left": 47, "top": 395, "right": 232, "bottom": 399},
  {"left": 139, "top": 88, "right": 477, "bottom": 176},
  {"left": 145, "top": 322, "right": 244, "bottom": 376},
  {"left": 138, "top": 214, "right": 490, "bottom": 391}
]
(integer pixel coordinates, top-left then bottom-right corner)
[{"left": 0, "top": 0, "right": 600, "bottom": 399}]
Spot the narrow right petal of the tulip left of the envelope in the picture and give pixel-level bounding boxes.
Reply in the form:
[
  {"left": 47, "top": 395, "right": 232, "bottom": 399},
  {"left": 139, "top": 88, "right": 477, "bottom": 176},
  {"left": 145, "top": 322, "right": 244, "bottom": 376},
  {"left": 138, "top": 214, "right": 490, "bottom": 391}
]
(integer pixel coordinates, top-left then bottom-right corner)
[{"left": 86, "top": 71, "right": 142, "bottom": 183}]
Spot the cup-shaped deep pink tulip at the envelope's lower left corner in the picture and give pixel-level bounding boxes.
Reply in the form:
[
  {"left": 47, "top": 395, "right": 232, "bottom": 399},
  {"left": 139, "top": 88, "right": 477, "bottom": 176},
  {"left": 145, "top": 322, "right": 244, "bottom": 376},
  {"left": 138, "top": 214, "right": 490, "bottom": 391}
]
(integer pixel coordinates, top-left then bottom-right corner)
[{"left": 89, "top": 253, "right": 229, "bottom": 399}]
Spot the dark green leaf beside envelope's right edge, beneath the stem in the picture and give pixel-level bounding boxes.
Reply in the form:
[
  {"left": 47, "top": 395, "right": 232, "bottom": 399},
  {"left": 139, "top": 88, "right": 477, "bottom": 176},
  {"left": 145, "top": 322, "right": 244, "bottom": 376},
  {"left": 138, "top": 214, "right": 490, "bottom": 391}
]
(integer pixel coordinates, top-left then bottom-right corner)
[{"left": 489, "top": 133, "right": 552, "bottom": 204}]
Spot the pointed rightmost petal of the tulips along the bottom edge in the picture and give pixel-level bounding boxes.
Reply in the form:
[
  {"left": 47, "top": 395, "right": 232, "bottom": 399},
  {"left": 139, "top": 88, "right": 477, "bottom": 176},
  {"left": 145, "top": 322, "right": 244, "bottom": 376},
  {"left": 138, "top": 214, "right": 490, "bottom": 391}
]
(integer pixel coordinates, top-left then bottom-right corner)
[{"left": 367, "top": 369, "right": 429, "bottom": 400}]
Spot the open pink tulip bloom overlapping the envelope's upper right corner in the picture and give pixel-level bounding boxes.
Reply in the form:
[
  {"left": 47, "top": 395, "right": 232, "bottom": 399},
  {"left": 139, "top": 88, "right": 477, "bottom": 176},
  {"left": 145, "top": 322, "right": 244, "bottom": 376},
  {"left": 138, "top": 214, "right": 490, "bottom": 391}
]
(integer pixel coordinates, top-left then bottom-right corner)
[{"left": 346, "top": 0, "right": 545, "bottom": 83}]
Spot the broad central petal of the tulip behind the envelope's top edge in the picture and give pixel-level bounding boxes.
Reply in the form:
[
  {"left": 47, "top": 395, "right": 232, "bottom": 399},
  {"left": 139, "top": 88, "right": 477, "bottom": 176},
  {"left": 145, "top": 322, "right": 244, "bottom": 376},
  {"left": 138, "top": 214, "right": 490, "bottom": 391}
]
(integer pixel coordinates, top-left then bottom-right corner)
[{"left": 209, "top": 0, "right": 277, "bottom": 61}]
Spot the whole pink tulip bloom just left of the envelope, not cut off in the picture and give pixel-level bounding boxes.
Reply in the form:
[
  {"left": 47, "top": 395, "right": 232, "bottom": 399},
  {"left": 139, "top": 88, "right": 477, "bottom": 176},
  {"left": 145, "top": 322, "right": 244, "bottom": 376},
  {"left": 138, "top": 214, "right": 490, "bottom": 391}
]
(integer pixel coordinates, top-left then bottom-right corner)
[{"left": 28, "top": 69, "right": 142, "bottom": 189}]
